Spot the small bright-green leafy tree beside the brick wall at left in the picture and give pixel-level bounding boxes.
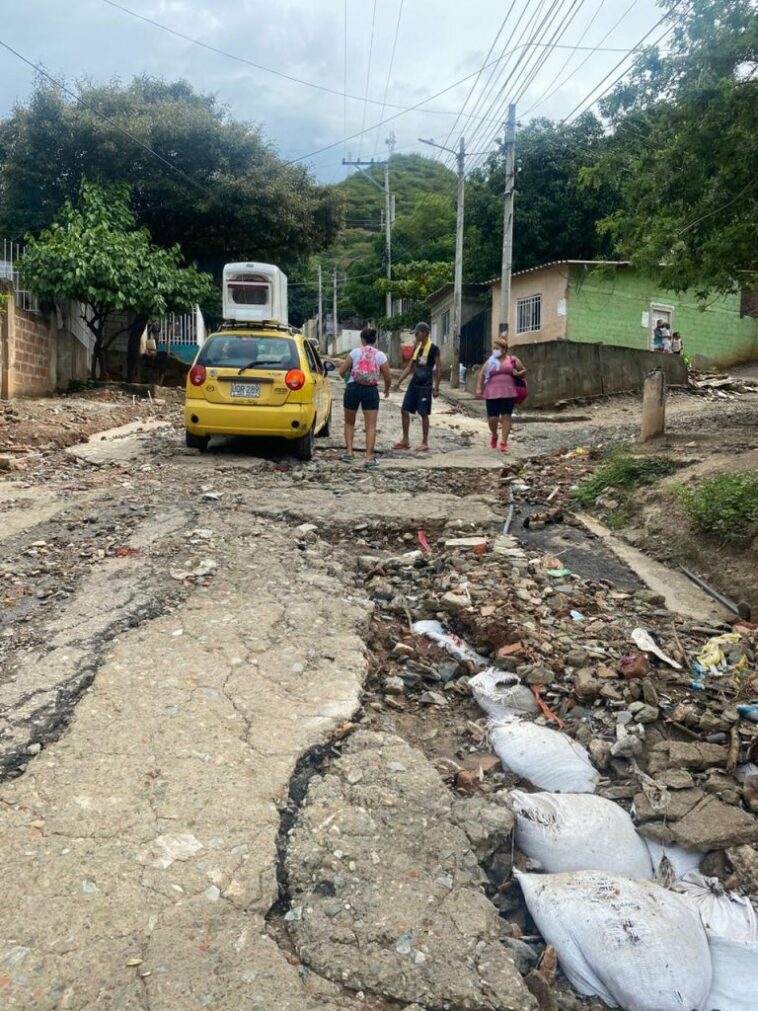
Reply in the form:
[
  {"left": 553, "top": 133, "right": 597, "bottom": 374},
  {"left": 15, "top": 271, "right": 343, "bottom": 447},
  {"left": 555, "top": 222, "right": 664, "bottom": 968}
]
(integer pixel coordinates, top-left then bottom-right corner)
[{"left": 21, "top": 180, "right": 212, "bottom": 377}]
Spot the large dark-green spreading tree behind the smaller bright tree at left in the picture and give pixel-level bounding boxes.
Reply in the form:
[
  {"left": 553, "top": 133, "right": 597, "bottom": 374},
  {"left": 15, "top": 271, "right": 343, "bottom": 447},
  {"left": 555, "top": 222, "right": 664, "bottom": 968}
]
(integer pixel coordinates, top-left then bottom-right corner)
[{"left": 0, "top": 77, "right": 343, "bottom": 277}]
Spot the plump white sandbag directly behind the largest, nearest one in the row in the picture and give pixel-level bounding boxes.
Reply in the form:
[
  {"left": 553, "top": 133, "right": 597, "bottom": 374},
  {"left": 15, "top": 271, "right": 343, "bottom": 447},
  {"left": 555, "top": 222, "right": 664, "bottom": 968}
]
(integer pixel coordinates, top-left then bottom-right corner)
[{"left": 510, "top": 790, "right": 653, "bottom": 880}]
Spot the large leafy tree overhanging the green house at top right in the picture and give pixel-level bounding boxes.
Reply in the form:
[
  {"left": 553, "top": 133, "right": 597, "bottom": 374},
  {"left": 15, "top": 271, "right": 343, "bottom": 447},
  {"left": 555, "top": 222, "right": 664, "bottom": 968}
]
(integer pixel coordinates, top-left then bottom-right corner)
[{"left": 585, "top": 0, "right": 758, "bottom": 297}]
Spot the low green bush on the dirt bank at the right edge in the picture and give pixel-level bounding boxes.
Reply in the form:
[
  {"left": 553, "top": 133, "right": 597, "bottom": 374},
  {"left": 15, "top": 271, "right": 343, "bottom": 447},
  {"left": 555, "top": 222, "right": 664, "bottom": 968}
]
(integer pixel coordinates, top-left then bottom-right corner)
[{"left": 677, "top": 470, "right": 758, "bottom": 547}]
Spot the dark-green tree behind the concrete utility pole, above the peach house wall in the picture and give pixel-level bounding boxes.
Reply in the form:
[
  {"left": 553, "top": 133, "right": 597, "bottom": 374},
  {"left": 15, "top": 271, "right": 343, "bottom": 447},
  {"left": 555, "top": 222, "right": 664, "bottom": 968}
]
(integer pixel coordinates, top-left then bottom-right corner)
[{"left": 464, "top": 114, "right": 619, "bottom": 282}]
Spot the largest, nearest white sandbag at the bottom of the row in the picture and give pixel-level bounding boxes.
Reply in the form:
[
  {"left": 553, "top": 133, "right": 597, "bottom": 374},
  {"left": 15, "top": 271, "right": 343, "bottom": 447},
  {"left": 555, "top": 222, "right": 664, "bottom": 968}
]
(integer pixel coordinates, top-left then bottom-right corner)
[{"left": 516, "top": 870, "right": 715, "bottom": 1011}]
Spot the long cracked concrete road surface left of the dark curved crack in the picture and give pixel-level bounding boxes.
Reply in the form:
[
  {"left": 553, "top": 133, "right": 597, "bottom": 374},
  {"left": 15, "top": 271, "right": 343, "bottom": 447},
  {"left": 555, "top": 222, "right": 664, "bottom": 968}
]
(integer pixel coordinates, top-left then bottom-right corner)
[{"left": 0, "top": 390, "right": 493, "bottom": 1011}]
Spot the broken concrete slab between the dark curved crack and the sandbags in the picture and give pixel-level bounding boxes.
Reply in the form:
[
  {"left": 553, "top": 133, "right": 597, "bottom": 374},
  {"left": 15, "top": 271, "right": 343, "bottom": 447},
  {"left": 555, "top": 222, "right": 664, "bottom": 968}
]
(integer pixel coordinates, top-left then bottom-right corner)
[{"left": 286, "top": 731, "right": 537, "bottom": 1011}]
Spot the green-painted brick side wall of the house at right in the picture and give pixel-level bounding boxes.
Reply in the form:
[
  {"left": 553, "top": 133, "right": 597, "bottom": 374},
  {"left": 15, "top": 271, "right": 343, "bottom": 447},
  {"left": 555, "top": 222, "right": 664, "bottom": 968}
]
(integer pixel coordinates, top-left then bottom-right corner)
[{"left": 566, "top": 265, "right": 758, "bottom": 368}]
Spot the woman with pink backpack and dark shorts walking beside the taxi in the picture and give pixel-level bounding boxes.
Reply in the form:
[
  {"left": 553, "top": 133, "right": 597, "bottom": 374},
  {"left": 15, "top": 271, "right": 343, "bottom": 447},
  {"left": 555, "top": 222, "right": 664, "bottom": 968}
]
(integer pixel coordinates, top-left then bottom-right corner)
[{"left": 340, "top": 327, "right": 392, "bottom": 467}]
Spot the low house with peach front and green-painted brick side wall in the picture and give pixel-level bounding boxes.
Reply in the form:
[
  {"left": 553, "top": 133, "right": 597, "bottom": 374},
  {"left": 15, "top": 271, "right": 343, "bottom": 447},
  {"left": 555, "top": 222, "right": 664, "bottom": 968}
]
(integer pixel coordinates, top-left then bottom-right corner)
[{"left": 491, "top": 260, "right": 758, "bottom": 368}]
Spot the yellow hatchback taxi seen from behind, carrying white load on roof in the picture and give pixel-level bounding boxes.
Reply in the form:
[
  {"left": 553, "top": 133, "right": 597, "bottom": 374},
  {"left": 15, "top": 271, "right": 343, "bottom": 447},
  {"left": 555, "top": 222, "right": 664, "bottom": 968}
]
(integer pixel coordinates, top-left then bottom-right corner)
[{"left": 184, "top": 323, "right": 335, "bottom": 460}]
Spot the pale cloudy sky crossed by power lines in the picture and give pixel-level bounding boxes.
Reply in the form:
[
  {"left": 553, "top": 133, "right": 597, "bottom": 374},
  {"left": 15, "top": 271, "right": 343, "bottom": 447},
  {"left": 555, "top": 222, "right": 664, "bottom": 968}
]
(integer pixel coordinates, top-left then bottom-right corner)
[{"left": 0, "top": 0, "right": 661, "bottom": 181}]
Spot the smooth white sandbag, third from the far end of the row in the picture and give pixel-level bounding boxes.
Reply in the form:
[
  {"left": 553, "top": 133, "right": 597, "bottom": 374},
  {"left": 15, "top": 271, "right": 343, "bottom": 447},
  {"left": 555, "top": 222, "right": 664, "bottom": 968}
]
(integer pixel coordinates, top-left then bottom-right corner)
[{"left": 489, "top": 720, "right": 600, "bottom": 794}]
